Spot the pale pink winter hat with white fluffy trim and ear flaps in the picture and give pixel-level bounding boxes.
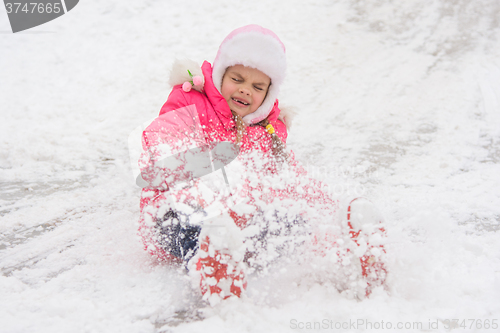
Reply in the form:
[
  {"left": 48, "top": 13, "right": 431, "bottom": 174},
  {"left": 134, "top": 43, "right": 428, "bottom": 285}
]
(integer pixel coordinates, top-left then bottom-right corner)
[{"left": 212, "top": 24, "right": 286, "bottom": 125}]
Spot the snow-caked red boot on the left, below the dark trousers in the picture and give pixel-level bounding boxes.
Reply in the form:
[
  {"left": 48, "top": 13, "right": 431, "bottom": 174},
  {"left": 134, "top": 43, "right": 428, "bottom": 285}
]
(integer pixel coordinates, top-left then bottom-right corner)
[{"left": 194, "top": 236, "right": 247, "bottom": 306}]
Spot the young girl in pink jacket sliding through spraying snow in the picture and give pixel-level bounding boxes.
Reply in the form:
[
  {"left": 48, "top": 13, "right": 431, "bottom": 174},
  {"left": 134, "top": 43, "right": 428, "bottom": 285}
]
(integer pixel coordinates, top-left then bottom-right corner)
[{"left": 139, "top": 25, "right": 385, "bottom": 304}]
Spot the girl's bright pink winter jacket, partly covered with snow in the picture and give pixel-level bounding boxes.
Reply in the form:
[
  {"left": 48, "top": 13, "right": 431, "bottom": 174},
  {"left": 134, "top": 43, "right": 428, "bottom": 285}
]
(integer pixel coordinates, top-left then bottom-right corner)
[{"left": 139, "top": 61, "right": 287, "bottom": 259}]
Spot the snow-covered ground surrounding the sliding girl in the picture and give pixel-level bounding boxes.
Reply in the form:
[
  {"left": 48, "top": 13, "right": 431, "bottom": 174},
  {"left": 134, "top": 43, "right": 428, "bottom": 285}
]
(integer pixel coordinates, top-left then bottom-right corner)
[{"left": 0, "top": 0, "right": 500, "bottom": 332}]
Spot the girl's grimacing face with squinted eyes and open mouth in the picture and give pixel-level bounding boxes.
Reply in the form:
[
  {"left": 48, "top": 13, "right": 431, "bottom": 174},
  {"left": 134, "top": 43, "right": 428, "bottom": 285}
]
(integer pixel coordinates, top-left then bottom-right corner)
[{"left": 221, "top": 65, "right": 271, "bottom": 117}]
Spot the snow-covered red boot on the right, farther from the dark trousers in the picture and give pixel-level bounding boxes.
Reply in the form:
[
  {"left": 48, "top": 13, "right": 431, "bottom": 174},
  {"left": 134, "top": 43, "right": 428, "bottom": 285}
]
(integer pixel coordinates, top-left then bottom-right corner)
[{"left": 347, "top": 198, "right": 387, "bottom": 296}]
